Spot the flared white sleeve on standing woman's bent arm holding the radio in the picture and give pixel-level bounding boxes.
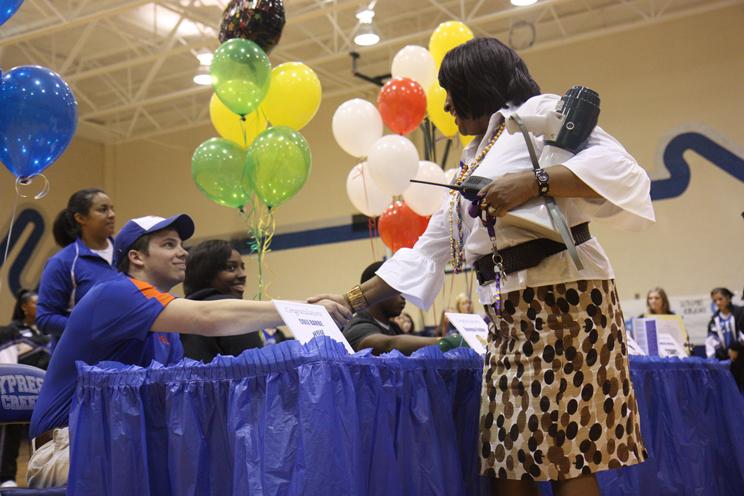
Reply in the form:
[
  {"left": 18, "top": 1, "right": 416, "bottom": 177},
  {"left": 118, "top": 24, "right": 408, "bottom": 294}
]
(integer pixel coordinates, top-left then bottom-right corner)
[{"left": 563, "top": 126, "right": 656, "bottom": 230}]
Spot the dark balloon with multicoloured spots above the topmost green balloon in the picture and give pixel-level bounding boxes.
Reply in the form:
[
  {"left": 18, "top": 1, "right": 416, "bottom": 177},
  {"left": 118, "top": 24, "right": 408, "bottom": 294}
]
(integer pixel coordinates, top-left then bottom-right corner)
[{"left": 220, "top": 0, "right": 287, "bottom": 53}]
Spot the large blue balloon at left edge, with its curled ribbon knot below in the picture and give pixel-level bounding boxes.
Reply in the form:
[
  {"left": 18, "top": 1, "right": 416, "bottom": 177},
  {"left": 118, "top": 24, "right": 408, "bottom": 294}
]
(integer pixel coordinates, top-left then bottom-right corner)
[{"left": 0, "top": 65, "right": 77, "bottom": 178}]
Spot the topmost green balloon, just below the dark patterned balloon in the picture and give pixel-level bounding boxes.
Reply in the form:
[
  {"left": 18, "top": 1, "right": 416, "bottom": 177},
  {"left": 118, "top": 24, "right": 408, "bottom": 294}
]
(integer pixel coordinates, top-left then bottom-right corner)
[{"left": 209, "top": 38, "right": 271, "bottom": 115}]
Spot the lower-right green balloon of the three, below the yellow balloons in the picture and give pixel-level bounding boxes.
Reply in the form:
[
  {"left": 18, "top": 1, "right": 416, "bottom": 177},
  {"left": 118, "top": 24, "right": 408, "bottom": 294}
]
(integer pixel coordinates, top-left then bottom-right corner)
[{"left": 244, "top": 126, "right": 312, "bottom": 208}]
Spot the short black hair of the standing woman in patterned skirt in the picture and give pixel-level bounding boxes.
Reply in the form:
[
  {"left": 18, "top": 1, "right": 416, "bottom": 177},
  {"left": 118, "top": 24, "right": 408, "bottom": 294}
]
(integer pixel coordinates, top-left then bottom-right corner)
[{"left": 439, "top": 38, "right": 540, "bottom": 119}]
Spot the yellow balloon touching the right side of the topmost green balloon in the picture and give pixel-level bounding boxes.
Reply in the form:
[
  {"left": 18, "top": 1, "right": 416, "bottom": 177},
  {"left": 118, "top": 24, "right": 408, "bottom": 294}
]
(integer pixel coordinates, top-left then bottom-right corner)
[{"left": 261, "top": 62, "right": 322, "bottom": 131}]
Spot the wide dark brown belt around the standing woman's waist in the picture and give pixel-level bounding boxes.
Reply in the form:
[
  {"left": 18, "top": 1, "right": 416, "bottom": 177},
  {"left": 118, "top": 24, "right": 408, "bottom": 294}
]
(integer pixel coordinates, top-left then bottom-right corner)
[{"left": 473, "top": 222, "right": 592, "bottom": 285}]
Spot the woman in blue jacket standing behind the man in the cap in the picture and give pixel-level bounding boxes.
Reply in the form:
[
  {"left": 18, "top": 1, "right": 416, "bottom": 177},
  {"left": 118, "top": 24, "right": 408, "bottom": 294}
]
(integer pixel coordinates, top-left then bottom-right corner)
[{"left": 36, "top": 188, "right": 117, "bottom": 342}]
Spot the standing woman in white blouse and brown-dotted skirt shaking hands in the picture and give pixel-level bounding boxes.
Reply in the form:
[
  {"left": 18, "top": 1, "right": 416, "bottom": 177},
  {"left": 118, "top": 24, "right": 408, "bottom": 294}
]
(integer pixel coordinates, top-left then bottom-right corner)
[{"left": 314, "top": 38, "right": 654, "bottom": 495}]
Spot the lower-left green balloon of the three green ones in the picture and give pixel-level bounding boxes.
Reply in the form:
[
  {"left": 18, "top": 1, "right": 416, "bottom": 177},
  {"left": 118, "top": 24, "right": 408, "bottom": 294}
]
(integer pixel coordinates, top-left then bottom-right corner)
[{"left": 191, "top": 138, "right": 249, "bottom": 208}]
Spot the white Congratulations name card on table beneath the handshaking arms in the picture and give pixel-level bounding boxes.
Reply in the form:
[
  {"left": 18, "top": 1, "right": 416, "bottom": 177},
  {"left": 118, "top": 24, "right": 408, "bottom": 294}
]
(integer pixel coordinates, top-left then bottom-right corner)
[{"left": 273, "top": 300, "right": 354, "bottom": 355}]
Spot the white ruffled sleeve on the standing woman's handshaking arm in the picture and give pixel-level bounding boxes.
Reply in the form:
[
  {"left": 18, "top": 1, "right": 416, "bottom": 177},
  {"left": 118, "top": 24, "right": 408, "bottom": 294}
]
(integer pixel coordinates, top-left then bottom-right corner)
[{"left": 377, "top": 200, "right": 460, "bottom": 309}]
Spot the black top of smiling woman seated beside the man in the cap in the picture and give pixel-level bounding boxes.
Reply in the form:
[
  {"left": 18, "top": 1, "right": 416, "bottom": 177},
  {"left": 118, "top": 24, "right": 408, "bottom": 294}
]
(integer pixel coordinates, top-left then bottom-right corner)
[{"left": 181, "top": 288, "right": 261, "bottom": 363}]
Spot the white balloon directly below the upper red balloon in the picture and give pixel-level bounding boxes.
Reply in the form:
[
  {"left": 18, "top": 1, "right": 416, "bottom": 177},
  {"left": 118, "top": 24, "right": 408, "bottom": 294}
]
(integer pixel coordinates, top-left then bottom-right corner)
[{"left": 367, "top": 134, "right": 418, "bottom": 195}]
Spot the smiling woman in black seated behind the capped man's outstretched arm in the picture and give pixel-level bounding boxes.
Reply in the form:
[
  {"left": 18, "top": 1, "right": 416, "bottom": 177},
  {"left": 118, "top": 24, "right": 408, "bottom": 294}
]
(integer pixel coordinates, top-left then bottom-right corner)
[{"left": 181, "top": 239, "right": 261, "bottom": 363}]
